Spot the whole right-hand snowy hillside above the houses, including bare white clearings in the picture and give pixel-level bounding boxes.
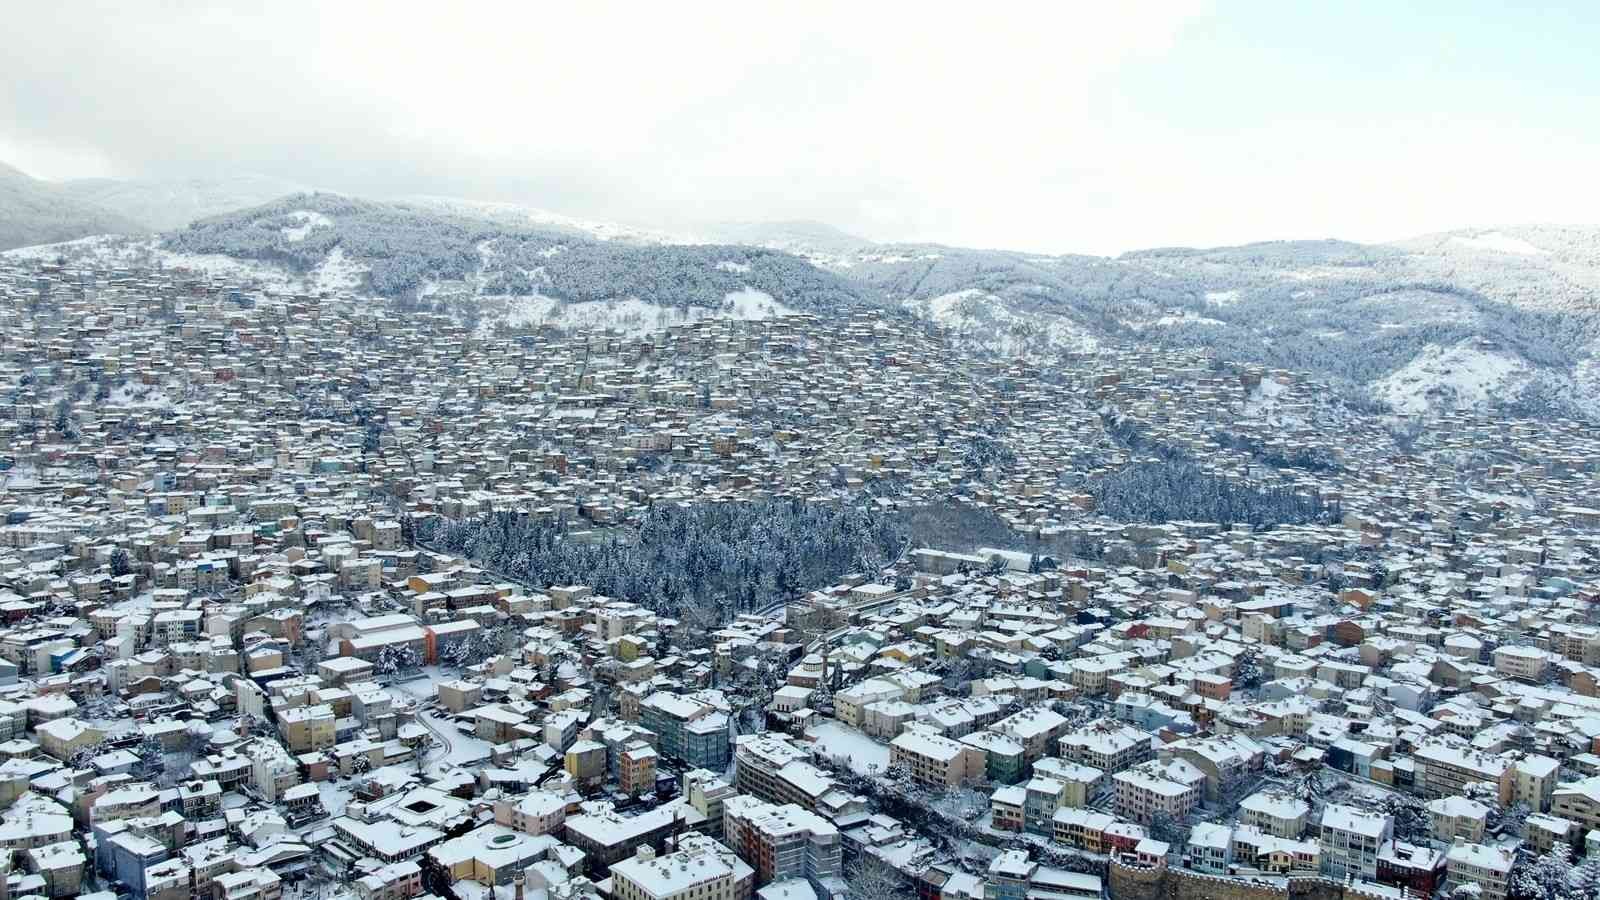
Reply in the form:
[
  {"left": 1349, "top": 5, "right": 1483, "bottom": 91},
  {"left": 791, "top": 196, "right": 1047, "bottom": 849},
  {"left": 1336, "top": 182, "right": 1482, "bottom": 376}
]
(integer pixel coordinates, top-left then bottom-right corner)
[{"left": 808, "top": 229, "right": 1600, "bottom": 416}]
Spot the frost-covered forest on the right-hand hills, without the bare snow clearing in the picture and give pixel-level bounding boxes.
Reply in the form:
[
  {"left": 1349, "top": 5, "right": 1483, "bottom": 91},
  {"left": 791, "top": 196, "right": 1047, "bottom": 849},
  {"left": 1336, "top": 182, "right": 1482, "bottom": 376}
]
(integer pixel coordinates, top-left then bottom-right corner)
[{"left": 846, "top": 240, "right": 1600, "bottom": 416}]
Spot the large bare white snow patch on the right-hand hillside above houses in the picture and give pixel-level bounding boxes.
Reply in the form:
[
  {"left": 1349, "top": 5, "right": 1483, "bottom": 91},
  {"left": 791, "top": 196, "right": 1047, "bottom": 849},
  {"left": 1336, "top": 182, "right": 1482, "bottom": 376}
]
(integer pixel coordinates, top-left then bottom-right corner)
[{"left": 1373, "top": 344, "right": 1530, "bottom": 413}]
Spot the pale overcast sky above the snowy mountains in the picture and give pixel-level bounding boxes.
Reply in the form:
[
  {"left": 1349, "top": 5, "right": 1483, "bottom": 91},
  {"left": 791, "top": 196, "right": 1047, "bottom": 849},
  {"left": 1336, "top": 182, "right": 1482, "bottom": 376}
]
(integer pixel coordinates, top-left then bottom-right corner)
[{"left": 0, "top": 0, "right": 1600, "bottom": 253}]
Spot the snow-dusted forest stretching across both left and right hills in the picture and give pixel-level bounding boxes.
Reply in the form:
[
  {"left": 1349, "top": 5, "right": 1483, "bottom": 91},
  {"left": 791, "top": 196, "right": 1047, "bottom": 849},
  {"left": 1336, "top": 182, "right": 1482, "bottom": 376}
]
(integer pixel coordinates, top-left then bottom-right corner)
[{"left": 163, "top": 194, "right": 1600, "bottom": 418}]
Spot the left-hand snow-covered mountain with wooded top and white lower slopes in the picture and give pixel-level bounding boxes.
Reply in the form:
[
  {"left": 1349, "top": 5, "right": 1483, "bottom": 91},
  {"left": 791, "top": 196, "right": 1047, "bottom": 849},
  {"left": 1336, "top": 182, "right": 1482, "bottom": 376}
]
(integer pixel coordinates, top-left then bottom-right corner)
[{"left": 14, "top": 194, "right": 877, "bottom": 330}]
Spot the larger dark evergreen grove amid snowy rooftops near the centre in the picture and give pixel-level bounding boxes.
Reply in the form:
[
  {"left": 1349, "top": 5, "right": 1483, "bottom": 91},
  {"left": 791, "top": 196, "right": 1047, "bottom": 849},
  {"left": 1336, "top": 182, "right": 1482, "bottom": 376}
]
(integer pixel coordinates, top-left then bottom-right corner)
[{"left": 418, "top": 500, "right": 907, "bottom": 620}]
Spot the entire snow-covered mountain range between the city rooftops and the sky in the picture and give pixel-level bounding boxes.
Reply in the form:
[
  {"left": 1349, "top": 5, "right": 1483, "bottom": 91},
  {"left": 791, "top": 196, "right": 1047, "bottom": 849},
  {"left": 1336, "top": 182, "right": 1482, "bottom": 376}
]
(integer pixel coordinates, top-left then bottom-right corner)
[{"left": 3, "top": 182, "right": 1600, "bottom": 416}]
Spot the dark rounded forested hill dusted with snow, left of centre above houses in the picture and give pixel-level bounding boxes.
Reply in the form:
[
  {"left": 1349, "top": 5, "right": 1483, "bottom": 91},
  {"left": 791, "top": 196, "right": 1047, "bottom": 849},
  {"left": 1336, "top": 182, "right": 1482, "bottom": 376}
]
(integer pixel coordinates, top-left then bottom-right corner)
[{"left": 165, "top": 194, "right": 878, "bottom": 312}]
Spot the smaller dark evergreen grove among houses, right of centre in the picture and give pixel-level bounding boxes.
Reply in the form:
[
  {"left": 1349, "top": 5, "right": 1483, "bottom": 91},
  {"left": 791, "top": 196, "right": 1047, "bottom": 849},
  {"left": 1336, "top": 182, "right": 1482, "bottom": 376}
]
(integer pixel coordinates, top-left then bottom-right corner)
[{"left": 1085, "top": 460, "right": 1339, "bottom": 525}]
